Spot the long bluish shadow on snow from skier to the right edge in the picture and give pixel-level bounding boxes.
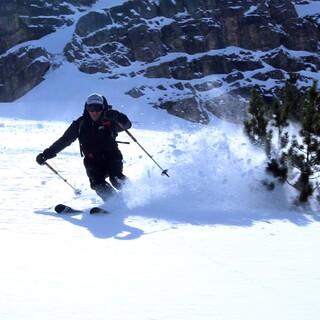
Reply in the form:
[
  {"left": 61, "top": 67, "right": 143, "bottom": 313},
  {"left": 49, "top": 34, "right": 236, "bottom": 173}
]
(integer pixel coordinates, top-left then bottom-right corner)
[{"left": 35, "top": 190, "right": 320, "bottom": 240}]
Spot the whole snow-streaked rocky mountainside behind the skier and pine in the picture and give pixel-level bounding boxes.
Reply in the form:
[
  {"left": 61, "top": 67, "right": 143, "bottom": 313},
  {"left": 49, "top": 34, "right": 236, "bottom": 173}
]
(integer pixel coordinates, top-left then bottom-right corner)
[{"left": 0, "top": 0, "right": 320, "bottom": 123}]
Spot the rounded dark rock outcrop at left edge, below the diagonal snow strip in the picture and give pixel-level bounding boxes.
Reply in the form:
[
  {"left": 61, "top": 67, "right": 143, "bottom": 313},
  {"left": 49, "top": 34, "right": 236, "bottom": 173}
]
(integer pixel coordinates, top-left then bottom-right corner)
[{"left": 0, "top": 47, "right": 50, "bottom": 102}]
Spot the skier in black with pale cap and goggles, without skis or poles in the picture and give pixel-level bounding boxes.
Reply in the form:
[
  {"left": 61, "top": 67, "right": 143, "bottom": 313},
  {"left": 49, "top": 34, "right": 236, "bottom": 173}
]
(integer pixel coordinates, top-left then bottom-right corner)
[{"left": 36, "top": 93, "right": 131, "bottom": 201}]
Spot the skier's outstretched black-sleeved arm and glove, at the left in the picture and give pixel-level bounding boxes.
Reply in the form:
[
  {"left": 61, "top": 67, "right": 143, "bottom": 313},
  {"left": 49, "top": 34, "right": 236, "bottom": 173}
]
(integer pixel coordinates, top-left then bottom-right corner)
[{"left": 36, "top": 121, "right": 79, "bottom": 165}]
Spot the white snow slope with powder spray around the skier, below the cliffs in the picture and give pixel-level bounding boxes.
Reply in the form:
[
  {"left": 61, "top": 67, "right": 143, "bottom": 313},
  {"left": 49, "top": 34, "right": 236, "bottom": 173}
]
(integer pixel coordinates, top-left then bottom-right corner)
[{"left": 0, "top": 1, "right": 320, "bottom": 320}]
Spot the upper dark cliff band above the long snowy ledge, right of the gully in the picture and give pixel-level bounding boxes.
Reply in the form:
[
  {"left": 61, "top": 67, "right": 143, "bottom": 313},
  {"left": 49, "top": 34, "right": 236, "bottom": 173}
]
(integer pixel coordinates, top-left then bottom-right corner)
[{"left": 65, "top": 0, "right": 320, "bottom": 72}]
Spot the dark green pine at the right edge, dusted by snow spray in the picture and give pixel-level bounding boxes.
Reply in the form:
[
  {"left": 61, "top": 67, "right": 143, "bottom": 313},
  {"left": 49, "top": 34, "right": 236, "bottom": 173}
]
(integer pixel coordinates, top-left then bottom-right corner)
[{"left": 244, "top": 81, "right": 320, "bottom": 203}]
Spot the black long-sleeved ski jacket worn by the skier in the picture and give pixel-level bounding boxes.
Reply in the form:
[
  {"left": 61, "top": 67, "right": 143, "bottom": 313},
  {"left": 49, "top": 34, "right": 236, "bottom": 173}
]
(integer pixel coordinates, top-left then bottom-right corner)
[{"left": 44, "top": 109, "right": 131, "bottom": 158}]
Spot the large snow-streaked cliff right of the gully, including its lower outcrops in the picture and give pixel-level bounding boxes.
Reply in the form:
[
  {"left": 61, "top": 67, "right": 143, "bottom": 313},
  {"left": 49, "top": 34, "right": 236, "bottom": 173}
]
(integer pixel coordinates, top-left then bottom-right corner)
[{"left": 60, "top": 0, "right": 320, "bottom": 123}]
